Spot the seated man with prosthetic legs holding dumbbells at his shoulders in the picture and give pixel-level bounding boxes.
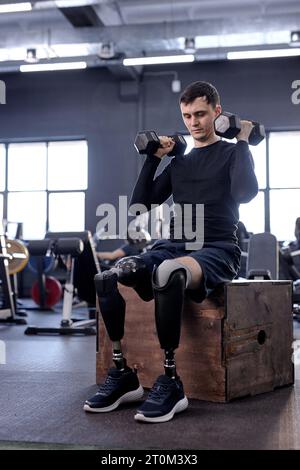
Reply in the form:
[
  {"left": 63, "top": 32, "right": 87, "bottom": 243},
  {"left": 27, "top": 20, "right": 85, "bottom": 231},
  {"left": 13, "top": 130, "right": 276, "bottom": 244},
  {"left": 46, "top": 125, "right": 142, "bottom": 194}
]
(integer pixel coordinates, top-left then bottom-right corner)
[{"left": 84, "top": 82, "right": 258, "bottom": 423}]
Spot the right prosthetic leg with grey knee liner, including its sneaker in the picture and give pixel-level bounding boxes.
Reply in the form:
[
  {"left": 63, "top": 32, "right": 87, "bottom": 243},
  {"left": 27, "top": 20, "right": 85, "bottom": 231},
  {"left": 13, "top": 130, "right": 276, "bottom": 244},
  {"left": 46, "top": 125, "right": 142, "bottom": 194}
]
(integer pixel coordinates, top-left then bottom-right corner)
[{"left": 134, "top": 260, "right": 192, "bottom": 423}]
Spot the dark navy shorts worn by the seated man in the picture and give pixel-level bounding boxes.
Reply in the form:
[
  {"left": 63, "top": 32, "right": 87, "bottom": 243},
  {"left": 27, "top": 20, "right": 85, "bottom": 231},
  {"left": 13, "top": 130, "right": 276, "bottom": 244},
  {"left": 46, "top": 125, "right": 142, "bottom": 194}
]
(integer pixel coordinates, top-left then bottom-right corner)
[{"left": 140, "top": 240, "right": 241, "bottom": 302}]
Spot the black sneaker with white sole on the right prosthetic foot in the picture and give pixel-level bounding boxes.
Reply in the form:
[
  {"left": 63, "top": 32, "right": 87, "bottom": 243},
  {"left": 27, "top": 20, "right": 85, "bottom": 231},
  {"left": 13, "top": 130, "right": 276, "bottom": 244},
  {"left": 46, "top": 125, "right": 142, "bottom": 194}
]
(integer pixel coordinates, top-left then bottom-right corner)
[{"left": 134, "top": 375, "right": 188, "bottom": 423}]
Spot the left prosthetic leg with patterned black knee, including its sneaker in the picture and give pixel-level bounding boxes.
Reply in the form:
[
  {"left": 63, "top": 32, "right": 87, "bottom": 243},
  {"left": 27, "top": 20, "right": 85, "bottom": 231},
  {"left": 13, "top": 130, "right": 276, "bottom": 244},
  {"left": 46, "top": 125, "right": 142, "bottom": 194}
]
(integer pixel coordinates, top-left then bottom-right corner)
[{"left": 83, "top": 256, "right": 152, "bottom": 413}]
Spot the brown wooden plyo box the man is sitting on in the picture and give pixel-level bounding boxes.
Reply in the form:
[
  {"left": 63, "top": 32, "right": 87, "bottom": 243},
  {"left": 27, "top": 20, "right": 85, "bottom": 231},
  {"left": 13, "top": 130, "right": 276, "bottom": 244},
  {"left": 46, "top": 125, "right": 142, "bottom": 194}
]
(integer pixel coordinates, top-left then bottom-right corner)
[{"left": 96, "top": 281, "right": 294, "bottom": 402}]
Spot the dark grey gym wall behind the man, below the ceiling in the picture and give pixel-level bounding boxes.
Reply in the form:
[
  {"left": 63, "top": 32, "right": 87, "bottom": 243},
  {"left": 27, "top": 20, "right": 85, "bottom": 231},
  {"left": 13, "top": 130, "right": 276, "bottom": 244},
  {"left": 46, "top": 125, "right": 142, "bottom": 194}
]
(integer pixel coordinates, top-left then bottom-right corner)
[{"left": 0, "top": 58, "right": 300, "bottom": 237}]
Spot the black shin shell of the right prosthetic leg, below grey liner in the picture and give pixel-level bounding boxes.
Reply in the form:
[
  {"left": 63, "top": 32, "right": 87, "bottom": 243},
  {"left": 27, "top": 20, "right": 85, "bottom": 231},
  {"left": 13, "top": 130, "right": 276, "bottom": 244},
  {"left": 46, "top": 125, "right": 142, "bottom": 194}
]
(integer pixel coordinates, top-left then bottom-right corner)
[{"left": 153, "top": 269, "right": 186, "bottom": 350}]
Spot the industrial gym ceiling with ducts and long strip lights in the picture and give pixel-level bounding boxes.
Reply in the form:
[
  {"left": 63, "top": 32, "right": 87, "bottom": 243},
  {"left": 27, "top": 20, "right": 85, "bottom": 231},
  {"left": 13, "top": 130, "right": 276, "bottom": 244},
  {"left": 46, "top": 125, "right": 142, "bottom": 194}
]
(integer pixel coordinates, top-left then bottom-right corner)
[{"left": 0, "top": 0, "right": 300, "bottom": 73}]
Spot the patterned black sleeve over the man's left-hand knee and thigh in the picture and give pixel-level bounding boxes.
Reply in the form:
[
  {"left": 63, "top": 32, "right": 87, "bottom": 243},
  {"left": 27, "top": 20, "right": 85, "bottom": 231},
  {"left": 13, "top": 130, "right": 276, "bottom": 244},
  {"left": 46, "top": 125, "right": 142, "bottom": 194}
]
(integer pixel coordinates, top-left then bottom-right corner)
[{"left": 115, "top": 256, "right": 153, "bottom": 301}]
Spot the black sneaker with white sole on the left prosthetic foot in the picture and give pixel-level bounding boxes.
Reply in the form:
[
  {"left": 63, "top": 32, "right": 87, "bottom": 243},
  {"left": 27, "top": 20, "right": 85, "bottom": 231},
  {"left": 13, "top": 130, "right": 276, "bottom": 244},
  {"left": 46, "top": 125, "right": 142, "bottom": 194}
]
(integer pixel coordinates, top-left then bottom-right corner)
[{"left": 83, "top": 367, "right": 144, "bottom": 413}]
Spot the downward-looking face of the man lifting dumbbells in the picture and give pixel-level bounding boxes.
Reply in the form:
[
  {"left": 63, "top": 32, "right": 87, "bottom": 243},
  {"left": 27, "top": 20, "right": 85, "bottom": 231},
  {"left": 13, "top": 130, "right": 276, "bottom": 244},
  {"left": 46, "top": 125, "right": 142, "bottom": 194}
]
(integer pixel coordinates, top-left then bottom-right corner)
[{"left": 180, "top": 96, "right": 221, "bottom": 147}]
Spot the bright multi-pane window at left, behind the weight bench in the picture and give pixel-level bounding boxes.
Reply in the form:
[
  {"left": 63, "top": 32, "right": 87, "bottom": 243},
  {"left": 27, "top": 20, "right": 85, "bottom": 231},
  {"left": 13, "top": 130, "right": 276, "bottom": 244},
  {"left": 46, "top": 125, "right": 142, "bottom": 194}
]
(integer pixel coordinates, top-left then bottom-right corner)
[{"left": 0, "top": 140, "right": 88, "bottom": 239}]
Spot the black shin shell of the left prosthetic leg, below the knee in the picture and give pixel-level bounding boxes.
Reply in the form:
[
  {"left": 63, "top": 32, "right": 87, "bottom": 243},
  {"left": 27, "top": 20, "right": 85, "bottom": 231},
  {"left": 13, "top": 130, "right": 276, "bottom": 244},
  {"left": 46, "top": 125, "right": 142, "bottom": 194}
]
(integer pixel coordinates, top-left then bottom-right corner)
[{"left": 95, "top": 270, "right": 126, "bottom": 341}]
